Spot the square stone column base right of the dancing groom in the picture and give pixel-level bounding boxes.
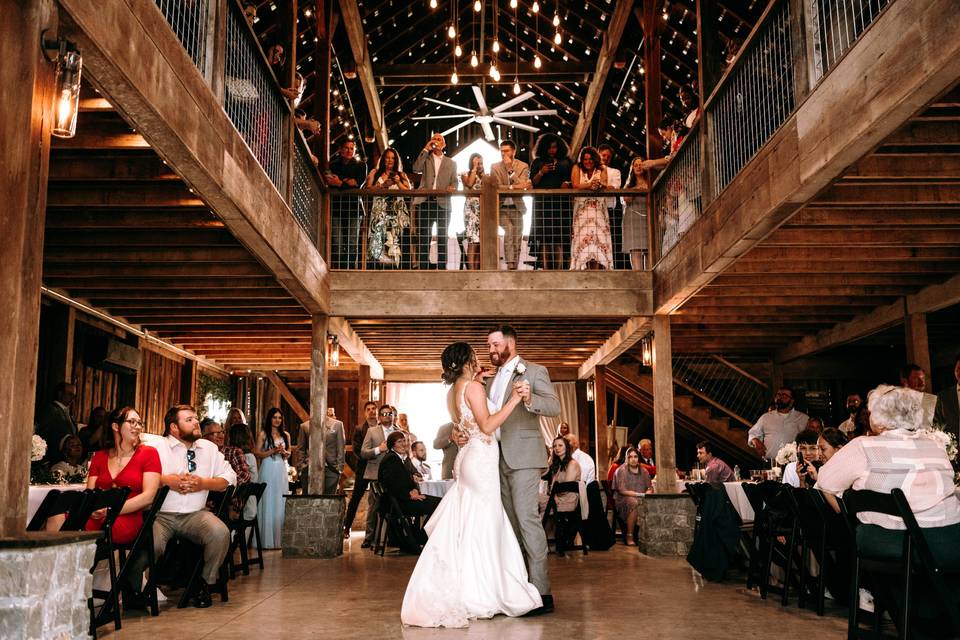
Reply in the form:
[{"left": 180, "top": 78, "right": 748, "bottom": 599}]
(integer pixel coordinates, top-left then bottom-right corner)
[{"left": 637, "top": 493, "right": 697, "bottom": 557}]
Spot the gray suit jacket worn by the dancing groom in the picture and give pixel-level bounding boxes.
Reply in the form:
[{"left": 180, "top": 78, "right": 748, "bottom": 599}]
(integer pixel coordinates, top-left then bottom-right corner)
[{"left": 487, "top": 358, "right": 560, "bottom": 469}]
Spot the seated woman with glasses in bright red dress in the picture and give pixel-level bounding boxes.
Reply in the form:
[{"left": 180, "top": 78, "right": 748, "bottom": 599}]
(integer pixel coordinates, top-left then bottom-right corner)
[{"left": 86, "top": 407, "right": 160, "bottom": 544}]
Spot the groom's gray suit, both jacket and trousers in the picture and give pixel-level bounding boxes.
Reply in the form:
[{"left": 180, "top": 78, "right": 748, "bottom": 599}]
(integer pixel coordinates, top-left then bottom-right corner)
[{"left": 487, "top": 358, "right": 560, "bottom": 594}]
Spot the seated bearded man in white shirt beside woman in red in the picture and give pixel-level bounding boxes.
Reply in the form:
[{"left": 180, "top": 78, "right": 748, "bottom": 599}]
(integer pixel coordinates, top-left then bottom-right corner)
[{"left": 149, "top": 404, "right": 237, "bottom": 608}]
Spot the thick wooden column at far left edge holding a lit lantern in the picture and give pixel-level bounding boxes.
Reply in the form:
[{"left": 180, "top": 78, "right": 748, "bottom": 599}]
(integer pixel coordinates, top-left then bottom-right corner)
[{"left": 0, "top": 0, "right": 57, "bottom": 536}]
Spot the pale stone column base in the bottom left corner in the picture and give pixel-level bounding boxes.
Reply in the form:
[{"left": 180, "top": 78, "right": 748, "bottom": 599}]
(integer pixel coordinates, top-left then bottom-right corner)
[{"left": 0, "top": 533, "right": 99, "bottom": 640}]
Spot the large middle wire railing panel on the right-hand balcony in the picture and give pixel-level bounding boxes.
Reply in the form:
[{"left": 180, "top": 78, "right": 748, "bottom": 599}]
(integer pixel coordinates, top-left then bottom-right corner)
[{"left": 705, "top": 2, "right": 796, "bottom": 195}]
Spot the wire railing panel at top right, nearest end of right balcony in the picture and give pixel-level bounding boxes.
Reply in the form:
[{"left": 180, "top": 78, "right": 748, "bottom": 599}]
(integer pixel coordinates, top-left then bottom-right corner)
[{"left": 806, "top": 0, "right": 892, "bottom": 82}]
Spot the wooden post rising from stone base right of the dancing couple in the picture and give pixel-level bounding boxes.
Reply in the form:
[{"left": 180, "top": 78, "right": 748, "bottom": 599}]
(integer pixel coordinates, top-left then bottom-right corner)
[{"left": 653, "top": 314, "right": 677, "bottom": 493}]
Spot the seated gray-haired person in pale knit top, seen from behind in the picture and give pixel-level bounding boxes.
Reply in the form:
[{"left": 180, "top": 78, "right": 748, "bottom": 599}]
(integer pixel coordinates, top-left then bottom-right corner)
[{"left": 816, "top": 385, "right": 960, "bottom": 635}]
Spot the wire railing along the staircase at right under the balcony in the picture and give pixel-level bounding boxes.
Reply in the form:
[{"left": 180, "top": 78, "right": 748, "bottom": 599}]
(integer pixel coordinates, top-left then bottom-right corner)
[{"left": 673, "top": 354, "right": 770, "bottom": 427}]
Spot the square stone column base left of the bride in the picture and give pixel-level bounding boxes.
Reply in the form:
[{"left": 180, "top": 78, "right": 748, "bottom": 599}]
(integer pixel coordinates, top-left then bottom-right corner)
[{"left": 280, "top": 495, "right": 347, "bottom": 558}]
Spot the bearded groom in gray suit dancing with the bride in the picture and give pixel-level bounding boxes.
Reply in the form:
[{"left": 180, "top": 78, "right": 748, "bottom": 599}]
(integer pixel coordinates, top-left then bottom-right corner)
[{"left": 476, "top": 324, "right": 560, "bottom": 613}]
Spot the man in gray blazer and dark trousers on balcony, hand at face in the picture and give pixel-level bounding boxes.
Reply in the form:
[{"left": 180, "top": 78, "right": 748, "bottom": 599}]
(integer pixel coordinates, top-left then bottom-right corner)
[{"left": 413, "top": 133, "right": 457, "bottom": 269}]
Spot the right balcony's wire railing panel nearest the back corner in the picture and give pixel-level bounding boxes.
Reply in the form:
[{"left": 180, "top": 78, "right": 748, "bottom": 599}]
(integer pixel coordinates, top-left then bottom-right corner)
[{"left": 651, "top": 123, "right": 703, "bottom": 256}]
